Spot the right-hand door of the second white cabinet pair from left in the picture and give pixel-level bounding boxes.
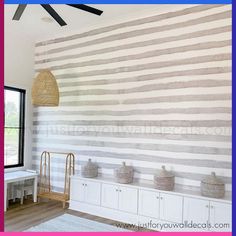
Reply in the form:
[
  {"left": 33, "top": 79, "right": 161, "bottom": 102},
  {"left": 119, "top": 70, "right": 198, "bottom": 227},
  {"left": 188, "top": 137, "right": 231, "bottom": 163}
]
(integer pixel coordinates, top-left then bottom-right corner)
[{"left": 119, "top": 187, "right": 138, "bottom": 214}]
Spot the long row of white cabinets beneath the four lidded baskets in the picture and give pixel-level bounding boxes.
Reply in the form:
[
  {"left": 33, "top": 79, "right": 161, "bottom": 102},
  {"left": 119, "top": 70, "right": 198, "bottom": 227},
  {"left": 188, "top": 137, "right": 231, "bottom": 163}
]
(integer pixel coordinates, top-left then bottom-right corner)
[{"left": 70, "top": 176, "right": 232, "bottom": 232}]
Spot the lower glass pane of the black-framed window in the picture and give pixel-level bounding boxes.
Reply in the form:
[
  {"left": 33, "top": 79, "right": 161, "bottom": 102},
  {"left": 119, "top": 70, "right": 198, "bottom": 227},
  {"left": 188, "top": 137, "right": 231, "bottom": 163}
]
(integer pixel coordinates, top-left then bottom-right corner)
[{"left": 4, "top": 128, "right": 19, "bottom": 166}]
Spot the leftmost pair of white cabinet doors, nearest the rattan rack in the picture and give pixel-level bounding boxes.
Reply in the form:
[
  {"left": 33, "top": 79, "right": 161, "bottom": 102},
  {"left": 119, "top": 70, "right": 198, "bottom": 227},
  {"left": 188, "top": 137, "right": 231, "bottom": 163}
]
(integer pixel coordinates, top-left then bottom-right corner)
[{"left": 70, "top": 179, "right": 101, "bottom": 205}]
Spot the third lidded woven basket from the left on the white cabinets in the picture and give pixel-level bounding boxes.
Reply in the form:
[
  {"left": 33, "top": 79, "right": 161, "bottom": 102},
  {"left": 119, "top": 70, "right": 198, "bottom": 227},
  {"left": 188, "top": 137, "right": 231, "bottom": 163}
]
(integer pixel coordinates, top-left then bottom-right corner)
[{"left": 154, "top": 166, "right": 175, "bottom": 191}]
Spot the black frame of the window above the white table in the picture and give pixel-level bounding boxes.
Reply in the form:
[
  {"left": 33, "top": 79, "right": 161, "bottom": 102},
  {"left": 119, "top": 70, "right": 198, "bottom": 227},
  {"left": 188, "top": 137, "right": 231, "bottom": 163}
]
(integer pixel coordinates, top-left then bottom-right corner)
[{"left": 4, "top": 86, "right": 26, "bottom": 169}]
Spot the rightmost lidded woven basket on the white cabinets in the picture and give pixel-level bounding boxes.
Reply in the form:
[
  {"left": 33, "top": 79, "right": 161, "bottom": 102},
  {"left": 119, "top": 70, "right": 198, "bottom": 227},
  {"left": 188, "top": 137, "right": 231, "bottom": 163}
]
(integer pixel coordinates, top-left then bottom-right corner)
[{"left": 201, "top": 172, "right": 225, "bottom": 198}]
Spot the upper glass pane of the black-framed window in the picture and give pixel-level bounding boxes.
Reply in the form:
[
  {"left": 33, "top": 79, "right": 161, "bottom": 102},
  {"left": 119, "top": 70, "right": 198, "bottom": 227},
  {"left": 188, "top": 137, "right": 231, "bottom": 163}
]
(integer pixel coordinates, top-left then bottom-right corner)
[{"left": 4, "top": 90, "right": 20, "bottom": 127}]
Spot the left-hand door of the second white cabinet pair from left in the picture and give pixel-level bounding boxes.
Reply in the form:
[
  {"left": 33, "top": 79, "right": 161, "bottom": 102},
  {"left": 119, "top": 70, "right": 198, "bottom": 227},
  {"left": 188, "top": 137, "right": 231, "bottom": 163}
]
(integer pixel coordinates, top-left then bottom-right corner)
[{"left": 101, "top": 184, "right": 119, "bottom": 209}]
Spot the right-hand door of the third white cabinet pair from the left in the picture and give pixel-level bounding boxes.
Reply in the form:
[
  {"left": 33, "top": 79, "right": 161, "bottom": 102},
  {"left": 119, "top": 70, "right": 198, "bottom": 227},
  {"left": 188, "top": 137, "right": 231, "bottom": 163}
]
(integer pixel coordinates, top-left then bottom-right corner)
[{"left": 160, "top": 193, "right": 183, "bottom": 223}]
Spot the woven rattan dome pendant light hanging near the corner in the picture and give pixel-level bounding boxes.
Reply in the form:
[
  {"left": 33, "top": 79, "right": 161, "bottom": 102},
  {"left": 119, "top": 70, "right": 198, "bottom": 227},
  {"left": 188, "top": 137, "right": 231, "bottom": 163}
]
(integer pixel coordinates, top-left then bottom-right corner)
[{"left": 31, "top": 70, "right": 59, "bottom": 106}]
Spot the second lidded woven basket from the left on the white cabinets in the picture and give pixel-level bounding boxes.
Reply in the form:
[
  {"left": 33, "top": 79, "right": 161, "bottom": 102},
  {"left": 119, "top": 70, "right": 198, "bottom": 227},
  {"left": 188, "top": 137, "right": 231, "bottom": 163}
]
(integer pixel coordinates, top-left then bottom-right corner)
[{"left": 114, "top": 162, "right": 134, "bottom": 184}]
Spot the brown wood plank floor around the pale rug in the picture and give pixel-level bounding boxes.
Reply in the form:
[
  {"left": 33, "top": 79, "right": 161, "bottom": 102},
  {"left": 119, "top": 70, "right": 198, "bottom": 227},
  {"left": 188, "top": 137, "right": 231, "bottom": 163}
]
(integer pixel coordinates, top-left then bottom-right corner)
[{"left": 5, "top": 199, "right": 150, "bottom": 232}]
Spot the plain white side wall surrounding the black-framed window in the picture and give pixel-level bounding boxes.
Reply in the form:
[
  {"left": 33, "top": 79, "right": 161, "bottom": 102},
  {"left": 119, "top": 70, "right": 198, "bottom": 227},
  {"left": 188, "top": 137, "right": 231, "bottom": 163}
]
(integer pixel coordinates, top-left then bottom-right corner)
[{"left": 4, "top": 23, "right": 34, "bottom": 171}]
